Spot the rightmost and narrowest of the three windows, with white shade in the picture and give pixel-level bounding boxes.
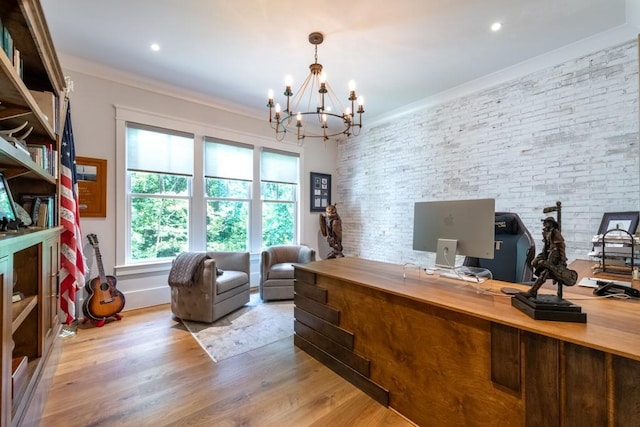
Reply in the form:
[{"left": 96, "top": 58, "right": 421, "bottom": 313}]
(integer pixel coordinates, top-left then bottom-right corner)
[{"left": 260, "top": 149, "right": 299, "bottom": 247}]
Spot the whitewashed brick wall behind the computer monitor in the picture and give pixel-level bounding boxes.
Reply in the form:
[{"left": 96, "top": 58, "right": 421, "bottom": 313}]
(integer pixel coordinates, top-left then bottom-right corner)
[{"left": 335, "top": 41, "right": 640, "bottom": 265}]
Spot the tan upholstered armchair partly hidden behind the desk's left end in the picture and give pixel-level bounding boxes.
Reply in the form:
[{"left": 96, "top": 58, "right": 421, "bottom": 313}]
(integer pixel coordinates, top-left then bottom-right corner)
[{"left": 260, "top": 245, "right": 316, "bottom": 301}]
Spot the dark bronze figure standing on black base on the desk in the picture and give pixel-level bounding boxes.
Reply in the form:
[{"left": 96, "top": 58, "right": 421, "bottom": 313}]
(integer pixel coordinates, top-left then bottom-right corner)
[{"left": 524, "top": 217, "right": 578, "bottom": 298}]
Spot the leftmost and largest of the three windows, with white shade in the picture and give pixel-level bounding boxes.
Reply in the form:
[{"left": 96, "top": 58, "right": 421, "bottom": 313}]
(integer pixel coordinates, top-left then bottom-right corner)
[{"left": 126, "top": 123, "right": 194, "bottom": 262}]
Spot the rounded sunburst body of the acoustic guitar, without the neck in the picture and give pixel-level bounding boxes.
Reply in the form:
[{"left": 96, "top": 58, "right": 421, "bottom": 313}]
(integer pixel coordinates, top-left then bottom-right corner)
[{"left": 82, "top": 276, "right": 124, "bottom": 321}]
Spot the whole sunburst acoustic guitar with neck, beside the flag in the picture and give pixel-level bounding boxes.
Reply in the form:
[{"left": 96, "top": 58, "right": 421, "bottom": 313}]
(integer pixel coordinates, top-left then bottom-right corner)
[{"left": 82, "top": 234, "right": 124, "bottom": 326}]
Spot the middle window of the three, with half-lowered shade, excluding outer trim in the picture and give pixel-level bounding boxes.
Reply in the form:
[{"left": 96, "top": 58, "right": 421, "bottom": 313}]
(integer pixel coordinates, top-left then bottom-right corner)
[{"left": 204, "top": 140, "right": 253, "bottom": 251}]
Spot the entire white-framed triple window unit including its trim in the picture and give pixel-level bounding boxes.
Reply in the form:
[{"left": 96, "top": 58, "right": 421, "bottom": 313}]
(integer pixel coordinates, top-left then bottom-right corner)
[{"left": 115, "top": 106, "right": 302, "bottom": 274}]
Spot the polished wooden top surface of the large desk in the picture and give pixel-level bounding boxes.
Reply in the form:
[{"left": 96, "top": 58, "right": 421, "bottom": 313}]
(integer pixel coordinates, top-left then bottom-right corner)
[{"left": 296, "top": 258, "right": 640, "bottom": 361}]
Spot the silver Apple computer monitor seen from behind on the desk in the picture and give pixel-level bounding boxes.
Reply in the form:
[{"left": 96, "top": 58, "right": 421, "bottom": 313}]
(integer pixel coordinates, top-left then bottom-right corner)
[{"left": 413, "top": 199, "right": 495, "bottom": 268}]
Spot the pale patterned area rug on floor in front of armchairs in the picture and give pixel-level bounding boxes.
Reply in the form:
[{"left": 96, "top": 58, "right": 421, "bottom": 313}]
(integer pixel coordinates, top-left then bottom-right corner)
[{"left": 183, "top": 292, "right": 293, "bottom": 363}]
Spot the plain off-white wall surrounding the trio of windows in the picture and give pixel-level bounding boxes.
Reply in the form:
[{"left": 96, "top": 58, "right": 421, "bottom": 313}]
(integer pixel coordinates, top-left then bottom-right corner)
[{"left": 62, "top": 67, "right": 337, "bottom": 310}]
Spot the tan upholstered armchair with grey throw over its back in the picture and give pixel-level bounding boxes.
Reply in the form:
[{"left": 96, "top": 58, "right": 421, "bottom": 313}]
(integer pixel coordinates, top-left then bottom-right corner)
[{"left": 170, "top": 252, "right": 250, "bottom": 323}]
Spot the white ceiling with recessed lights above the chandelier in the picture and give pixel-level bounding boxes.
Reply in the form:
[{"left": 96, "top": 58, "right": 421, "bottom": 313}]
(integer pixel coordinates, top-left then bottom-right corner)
[{"left": 41, "top": 0, "right": 637, "bottom": 119}]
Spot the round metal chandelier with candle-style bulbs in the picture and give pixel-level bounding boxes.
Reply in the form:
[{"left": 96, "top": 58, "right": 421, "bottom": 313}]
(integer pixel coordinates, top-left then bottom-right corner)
[{"left": 267, "top": 32, "right": 364, "bottom": 141}]
